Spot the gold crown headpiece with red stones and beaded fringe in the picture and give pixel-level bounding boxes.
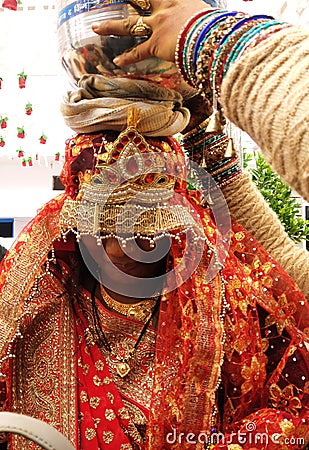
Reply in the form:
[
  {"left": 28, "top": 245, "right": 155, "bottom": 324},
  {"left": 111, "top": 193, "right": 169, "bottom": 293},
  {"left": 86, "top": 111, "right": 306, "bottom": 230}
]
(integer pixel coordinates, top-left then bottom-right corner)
[{"left": 60, "top": 109, "right": 204, "bottom": 245}]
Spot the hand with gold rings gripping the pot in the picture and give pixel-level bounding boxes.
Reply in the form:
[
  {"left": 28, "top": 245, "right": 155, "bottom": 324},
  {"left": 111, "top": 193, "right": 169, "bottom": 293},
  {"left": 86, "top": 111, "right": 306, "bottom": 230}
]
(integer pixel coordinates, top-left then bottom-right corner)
[{"left": 92, "top": 0, "right": 212, "bottom": 67}]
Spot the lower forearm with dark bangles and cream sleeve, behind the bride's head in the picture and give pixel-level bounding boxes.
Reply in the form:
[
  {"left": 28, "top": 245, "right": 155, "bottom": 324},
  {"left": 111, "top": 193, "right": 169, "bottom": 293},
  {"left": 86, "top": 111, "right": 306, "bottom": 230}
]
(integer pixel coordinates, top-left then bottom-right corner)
[{"left": 183, "top": 115, "right": 309, "bottom": 299}]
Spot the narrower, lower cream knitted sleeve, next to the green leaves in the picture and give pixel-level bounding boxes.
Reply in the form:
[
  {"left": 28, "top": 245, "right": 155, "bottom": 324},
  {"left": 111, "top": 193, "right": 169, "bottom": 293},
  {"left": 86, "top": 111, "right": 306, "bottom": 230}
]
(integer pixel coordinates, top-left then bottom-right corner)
[{"left": 221, "top": 173, "right": 309, "bottom": 300}]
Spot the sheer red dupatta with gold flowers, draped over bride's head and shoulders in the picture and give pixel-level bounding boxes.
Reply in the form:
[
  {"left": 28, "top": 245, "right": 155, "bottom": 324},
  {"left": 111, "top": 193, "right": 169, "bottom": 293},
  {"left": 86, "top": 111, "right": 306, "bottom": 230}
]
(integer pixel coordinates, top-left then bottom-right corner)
[{"left": 0, "top": 134, "right": 309, "bottom": 450}]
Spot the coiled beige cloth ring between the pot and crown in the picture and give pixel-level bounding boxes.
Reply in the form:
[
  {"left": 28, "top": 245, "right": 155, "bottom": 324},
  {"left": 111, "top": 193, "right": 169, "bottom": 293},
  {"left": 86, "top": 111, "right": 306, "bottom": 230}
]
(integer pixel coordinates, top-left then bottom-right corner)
[{"left": 60, "top": 75, "right": 190, "bottom": 136}]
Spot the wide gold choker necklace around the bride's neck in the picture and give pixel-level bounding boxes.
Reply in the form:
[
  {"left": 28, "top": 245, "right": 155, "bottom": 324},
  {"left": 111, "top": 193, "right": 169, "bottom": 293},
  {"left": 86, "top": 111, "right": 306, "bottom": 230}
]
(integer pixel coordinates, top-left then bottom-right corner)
[{"left": 100, "top": 284, "right": 159, "bottom": 322}]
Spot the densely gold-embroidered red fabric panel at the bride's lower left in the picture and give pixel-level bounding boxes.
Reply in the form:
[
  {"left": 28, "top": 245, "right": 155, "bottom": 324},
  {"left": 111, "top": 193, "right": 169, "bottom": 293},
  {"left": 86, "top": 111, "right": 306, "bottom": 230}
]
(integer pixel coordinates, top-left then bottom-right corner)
[{"left": 10, "top": 276, "right": 77, "bottom": 450}]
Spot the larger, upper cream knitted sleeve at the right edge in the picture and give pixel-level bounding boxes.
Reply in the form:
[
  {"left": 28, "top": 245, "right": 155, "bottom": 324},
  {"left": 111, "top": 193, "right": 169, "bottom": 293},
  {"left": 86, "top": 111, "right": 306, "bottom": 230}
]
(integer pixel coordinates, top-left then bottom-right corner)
[{"left": 220, "top": 26, "right": 309, "bottom": 201}]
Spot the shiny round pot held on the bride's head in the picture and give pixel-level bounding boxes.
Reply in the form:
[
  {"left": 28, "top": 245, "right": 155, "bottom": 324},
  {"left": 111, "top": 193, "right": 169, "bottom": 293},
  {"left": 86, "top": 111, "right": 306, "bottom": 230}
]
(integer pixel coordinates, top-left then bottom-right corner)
[{"left": 57, "top": 0, "right": 180, "bottom": 89}]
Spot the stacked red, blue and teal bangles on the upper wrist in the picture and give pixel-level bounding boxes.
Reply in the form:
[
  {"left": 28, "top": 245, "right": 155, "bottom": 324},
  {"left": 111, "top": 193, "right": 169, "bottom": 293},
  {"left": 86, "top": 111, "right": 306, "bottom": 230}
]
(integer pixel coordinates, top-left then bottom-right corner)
[{"left": 175, "top": 9, "right": 290, "bottom": 100}]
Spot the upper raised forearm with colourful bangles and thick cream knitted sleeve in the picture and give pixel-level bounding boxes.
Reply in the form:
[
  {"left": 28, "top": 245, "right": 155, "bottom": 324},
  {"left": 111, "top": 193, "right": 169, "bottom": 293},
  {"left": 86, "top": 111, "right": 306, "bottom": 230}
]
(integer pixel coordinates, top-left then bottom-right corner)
[{"left": 176, "top": 12, "right": 309, "bottom": 200}]
